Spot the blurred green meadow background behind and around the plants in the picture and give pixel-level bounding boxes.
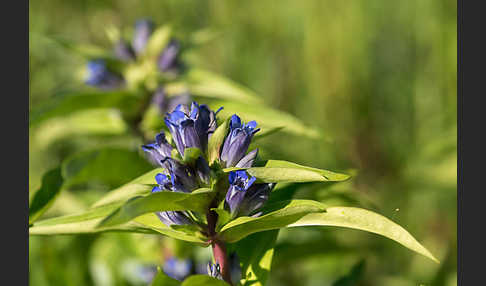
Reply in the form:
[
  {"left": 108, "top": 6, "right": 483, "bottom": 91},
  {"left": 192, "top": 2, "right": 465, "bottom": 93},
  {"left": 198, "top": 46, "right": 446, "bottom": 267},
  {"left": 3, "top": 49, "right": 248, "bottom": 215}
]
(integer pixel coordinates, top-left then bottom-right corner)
[{"left": 29, "top": 0, "right": 457, "bottom": 286}]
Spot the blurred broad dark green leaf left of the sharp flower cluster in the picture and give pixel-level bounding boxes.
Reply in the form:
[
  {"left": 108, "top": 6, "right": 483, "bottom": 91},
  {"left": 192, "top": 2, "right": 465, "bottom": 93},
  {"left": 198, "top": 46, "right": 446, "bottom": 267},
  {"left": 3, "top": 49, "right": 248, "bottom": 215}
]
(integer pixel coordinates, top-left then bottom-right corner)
[{"left": 62, "top": 148, "right": 153, "bottom": 188}]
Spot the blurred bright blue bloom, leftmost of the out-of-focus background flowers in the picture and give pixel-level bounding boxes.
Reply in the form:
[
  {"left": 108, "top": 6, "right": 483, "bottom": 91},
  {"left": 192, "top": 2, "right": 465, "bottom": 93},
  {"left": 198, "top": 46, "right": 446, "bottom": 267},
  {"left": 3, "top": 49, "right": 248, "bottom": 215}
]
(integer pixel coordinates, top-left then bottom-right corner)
[{"left": 85, "top": 60, "right": 125, "bottom": 89}]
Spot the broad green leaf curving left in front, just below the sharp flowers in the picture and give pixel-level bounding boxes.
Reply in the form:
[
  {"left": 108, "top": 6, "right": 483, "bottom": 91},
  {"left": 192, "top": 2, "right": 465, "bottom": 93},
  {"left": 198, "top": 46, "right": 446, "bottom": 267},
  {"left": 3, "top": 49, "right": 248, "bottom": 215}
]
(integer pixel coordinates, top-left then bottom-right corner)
[{"left": 100, "top": 189, "right": 214, "bottom": 227}]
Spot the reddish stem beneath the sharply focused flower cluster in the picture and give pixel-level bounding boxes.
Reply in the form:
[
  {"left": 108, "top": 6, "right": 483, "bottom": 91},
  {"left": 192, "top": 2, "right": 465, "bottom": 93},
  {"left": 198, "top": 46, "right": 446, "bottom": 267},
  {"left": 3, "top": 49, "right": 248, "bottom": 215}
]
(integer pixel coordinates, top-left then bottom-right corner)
[{"left": 206, "top": 211, "right": 233, "bottom": 285}]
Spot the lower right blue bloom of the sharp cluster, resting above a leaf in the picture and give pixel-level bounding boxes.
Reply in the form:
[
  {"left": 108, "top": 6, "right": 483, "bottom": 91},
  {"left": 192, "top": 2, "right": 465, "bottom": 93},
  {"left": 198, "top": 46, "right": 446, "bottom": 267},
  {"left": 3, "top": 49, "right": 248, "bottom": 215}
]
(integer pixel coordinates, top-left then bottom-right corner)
[{"left": 225, "top": 170, "right": 274, "bottom": 217}]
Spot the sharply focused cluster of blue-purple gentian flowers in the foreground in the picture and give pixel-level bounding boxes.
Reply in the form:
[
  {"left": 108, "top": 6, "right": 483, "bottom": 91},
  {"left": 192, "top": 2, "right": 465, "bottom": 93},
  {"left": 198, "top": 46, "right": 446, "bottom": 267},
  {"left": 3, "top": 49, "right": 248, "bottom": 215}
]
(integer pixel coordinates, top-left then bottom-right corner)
[{"left": 142, "top": 102, "right": 274, "bottom": 226}]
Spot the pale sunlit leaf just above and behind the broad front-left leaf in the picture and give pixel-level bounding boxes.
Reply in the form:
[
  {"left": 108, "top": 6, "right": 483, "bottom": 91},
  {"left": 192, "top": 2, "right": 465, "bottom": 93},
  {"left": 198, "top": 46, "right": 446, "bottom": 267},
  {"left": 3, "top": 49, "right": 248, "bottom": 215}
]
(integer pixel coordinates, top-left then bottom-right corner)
[{"left": 93, "top": 168, "right": 164, "bottom": 207}]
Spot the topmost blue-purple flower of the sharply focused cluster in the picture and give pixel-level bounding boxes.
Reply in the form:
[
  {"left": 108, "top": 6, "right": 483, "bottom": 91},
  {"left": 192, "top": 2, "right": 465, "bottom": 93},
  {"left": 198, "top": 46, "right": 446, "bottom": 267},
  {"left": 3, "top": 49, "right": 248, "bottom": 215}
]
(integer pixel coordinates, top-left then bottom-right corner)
[{"left": 165, "top": 102, "right": 216, "bottom": 156}]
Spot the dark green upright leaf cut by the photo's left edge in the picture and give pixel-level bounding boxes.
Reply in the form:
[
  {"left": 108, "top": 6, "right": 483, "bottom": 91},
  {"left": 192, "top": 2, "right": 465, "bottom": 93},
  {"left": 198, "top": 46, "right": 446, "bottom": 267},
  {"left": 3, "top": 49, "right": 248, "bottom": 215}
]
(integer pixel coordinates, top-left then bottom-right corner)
[{"left": 29, "top": 167, "right": 64, "bottom": 224}]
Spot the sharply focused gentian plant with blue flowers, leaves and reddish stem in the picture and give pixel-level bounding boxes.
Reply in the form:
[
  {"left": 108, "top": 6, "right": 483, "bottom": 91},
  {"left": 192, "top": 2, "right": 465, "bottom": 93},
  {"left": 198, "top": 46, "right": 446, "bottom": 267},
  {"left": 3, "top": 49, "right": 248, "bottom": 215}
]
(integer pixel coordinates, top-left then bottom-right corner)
[{"left": 30, "top": 102, "right": 436, "bottom": 285}]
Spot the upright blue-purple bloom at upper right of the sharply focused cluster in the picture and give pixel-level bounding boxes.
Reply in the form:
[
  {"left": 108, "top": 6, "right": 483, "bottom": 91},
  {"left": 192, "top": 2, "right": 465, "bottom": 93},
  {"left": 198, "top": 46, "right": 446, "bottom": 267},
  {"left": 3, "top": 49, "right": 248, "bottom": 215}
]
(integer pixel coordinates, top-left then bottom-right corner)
[{"left": 220, "top": 114, "right": 260, "bottom": 167}]
